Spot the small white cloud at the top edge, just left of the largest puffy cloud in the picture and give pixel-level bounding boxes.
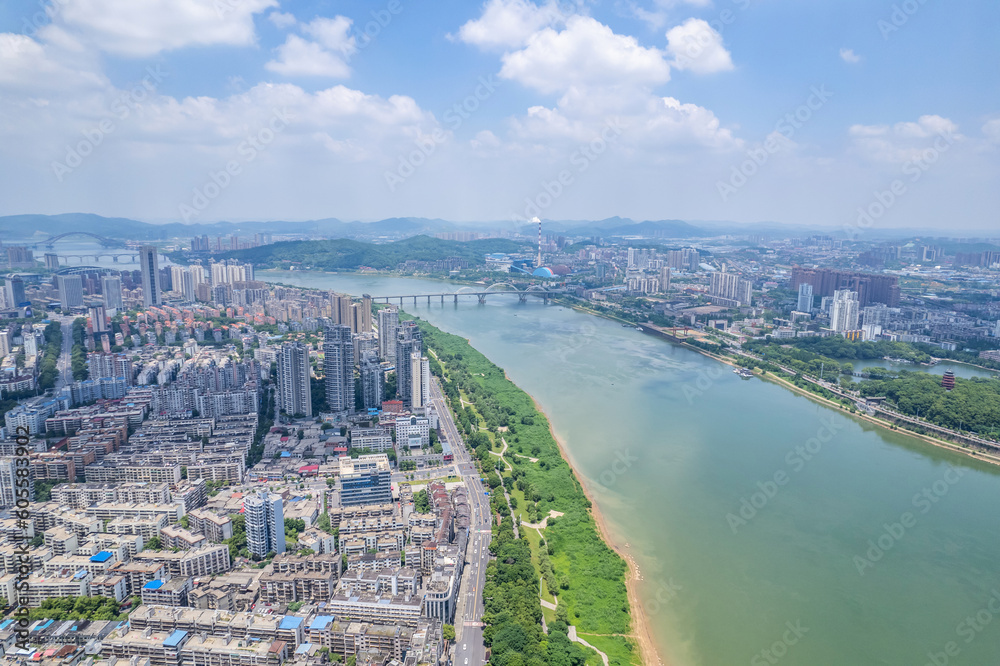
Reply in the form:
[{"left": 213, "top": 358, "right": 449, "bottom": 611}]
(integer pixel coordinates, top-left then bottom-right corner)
[{"left": 458, "top": 0, "right": 563, "bottom": 49}]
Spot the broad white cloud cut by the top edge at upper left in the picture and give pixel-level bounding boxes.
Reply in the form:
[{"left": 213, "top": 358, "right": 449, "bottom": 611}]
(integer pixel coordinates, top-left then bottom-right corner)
[{"left": 51, "top": 0, "right": 278, "bottom": 57}]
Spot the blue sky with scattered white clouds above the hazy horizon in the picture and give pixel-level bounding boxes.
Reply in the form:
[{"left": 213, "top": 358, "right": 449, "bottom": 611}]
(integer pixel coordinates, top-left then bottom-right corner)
[{"left": 0, "top": 0, "right": 1000, "bottom": 236}]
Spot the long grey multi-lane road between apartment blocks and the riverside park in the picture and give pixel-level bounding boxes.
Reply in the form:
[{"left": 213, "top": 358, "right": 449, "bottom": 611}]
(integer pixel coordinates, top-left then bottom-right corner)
[{"left": 431, "top": 378, "right": 492, "bottom": 666}]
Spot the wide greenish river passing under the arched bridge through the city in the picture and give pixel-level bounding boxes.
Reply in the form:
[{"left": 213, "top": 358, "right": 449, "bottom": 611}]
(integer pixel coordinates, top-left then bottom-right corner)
[{"left": 259, "top": 272, "right": 1000, "bottom": 666}]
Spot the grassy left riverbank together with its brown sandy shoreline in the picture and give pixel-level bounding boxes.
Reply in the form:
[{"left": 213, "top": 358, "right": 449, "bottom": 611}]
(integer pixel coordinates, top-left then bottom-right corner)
[{"left": 418, "top": 320, "right": 640, "bottom": 666}]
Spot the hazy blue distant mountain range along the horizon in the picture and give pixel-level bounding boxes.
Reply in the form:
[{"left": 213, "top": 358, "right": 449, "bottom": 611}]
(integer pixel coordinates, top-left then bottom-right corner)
[{"left": 0, "top": 213, "right": 982, "bottom": 243}]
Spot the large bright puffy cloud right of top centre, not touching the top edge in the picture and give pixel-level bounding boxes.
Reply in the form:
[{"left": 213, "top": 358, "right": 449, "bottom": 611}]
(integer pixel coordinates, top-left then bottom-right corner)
[{"left": 500, "top": 16, "right": 670, "bottom": 93}]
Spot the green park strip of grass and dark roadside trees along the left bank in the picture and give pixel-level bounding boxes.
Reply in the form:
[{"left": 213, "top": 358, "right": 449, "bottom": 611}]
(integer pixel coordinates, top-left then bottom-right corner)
[{"left": 419, "top": 321, "right": 637, "bottom": 666}]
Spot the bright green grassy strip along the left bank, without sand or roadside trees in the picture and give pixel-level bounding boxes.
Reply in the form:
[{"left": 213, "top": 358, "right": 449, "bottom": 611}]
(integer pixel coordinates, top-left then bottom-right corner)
[{"left": 419, "top": 314, "right": 632, "bottom": 652}]
